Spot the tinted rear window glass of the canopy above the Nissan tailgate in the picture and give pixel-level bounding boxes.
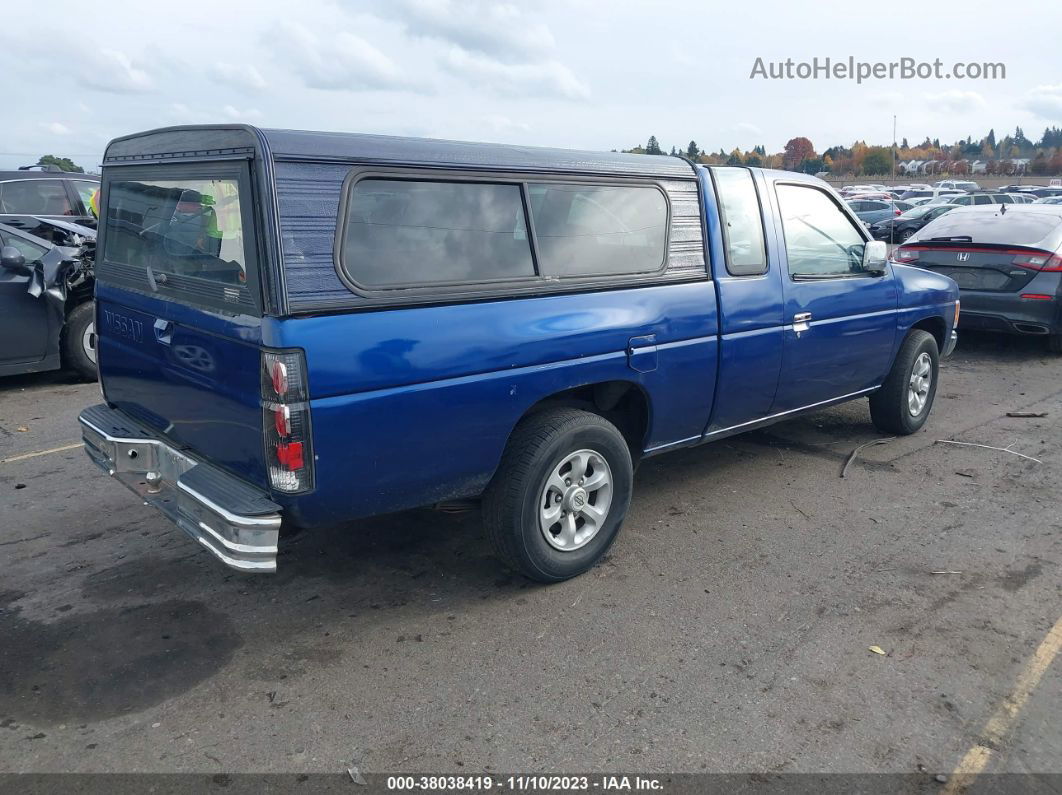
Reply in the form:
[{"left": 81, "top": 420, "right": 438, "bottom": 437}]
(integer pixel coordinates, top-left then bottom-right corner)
[{"left": 104, "top": 177, "right": 247, "bottom": 295}]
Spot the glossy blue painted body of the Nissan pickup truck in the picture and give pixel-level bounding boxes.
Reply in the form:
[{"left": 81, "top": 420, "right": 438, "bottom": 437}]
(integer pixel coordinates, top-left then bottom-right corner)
[{"left": 89, "top": 127, "right": 957, "bottom": 525}]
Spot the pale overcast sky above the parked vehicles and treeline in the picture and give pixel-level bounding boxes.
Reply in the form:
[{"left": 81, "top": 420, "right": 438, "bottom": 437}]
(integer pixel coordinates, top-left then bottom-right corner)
[{"left": 0, "top": 0, "right": 1062, "bottom": 169}]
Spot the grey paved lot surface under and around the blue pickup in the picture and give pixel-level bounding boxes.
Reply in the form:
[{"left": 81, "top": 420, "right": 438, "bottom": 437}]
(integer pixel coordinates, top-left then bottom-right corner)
[{"left": 0, "top": 335, "right": 1062, "bottom": 774}]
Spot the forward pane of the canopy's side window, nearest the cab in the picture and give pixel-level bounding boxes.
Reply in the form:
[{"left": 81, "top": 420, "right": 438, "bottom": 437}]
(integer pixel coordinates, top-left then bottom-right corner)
[{"left": 528, "top": 184, "right": 667, "bottom": 276}]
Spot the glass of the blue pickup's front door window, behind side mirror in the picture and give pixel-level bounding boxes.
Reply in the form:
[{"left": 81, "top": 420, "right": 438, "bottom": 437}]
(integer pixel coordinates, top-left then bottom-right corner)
[{"left": 777, "top": 185, "right": 866, "bottom": 276}]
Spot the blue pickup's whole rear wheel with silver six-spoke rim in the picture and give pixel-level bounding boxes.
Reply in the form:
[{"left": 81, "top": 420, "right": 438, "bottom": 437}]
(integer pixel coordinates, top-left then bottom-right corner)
[{"left": 483, "top": 409, "right": 634, "bottom": 583}]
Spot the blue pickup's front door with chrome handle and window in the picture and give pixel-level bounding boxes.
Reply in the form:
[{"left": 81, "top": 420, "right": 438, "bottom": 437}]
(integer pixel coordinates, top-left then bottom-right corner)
[{"left": 771, "top": 182, "right": 898, "bottom": 414}]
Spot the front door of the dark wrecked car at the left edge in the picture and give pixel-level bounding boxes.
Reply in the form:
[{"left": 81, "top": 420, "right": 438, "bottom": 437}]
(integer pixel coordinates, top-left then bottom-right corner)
[{"left": 0, "top": 231, "right": 52, "bottom": 366}]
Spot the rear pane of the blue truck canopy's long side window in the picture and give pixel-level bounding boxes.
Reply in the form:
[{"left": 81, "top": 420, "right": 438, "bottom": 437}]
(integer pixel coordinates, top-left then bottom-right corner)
[{"left": 342, "top": 178, "right": 534, "bottom": 289}]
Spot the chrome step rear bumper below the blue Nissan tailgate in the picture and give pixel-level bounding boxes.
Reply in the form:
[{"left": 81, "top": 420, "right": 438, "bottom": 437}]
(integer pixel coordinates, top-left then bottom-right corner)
[{"left": 78, "top": 404, "right": 280, "bottom": 572}]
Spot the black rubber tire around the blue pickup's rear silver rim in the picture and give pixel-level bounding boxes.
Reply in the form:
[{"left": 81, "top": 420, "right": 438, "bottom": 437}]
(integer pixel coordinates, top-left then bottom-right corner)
[{"left": 483, "top": 409, "right": 634, "bottom": 583}]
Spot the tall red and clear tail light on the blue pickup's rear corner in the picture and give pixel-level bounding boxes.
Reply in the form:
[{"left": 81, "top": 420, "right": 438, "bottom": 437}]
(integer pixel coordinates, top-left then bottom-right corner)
[{"left": 261, "top": 350, "right": 313, "bottom": 494}]
